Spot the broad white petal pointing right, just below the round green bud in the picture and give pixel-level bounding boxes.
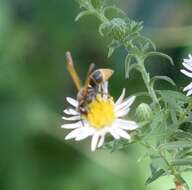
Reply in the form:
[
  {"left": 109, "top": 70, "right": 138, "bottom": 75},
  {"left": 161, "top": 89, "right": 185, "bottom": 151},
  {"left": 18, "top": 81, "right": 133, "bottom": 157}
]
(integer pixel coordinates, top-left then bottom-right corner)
[{"left": 113, "top": 119, "right": 138, "bottom": 130}]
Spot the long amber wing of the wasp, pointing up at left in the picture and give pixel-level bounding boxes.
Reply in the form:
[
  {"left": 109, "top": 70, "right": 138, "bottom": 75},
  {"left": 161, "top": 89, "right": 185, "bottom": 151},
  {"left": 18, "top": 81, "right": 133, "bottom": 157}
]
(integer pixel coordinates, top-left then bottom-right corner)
[{"left": 65, "top": 51, "right": 81, "bottom": 91}]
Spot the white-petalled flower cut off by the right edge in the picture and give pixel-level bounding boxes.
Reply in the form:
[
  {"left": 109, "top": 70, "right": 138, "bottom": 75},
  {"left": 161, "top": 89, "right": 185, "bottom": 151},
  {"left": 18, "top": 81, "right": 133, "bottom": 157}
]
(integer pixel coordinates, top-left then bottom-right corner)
[{"left": 180, "top": 54, "right": 192, "bottom": 96}]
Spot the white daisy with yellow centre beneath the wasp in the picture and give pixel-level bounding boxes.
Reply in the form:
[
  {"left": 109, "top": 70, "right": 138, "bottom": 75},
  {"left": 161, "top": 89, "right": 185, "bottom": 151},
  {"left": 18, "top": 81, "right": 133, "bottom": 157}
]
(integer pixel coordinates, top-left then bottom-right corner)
[{"left": 61, "top": 85, "right": 138, "bottom": 151}]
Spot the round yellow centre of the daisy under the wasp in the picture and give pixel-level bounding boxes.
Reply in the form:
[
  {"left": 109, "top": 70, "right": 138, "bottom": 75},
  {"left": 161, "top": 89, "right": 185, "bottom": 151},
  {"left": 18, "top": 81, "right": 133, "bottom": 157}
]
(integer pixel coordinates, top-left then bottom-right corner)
[{"left": 83, "top": 95, "right": 115, "bottom": 129}]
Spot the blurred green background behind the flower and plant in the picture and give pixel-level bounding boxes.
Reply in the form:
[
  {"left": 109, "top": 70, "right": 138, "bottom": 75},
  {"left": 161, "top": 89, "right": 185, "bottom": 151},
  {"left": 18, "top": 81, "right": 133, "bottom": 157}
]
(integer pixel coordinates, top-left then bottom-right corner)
[{"left": 0, "top": 0, "right": 192, "bottom": 190}]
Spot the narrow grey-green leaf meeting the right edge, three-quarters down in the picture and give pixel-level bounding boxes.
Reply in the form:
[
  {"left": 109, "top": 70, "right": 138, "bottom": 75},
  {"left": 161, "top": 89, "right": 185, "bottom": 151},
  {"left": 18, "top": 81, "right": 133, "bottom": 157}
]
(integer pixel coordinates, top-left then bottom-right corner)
[{"left": 159, "top": 141, "right": 192, "bottom": 150}]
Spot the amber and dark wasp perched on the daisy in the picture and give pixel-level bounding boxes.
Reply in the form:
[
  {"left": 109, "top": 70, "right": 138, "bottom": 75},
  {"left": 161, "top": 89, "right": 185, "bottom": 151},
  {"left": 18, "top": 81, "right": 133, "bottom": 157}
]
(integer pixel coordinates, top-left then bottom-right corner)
[{"left": 66, "top": 52, "right": 113, "bottom": 114}]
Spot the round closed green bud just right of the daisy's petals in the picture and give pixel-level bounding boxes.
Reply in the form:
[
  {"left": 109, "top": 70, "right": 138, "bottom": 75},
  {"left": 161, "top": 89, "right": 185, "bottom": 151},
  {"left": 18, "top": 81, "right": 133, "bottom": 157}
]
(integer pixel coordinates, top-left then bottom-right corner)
[{"left": 135, "top": 103, "right": 153, "bottom": 121}]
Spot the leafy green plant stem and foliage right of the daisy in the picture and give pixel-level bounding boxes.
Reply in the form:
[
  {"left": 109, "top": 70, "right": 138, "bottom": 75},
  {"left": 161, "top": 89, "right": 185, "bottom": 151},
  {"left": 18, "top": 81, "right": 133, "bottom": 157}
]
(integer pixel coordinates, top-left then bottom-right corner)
[{"left": 74, "top": 0, "right": 192, "bottom": 189}]
